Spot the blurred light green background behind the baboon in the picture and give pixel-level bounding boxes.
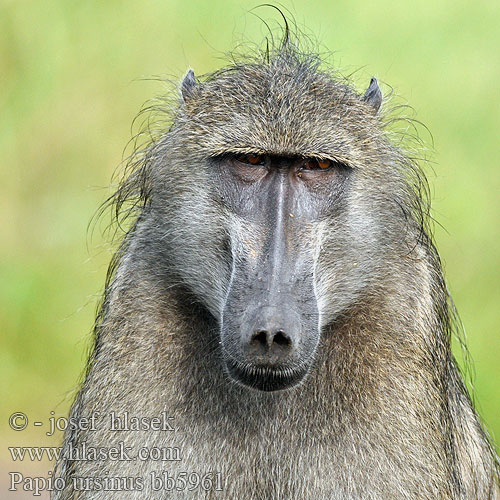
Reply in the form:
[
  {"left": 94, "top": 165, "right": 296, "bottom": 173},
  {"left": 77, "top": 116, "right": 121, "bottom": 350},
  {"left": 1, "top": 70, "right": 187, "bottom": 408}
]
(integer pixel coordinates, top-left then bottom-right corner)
[{"left": 0, "top": 0, "right": 500, "bottom": 492}]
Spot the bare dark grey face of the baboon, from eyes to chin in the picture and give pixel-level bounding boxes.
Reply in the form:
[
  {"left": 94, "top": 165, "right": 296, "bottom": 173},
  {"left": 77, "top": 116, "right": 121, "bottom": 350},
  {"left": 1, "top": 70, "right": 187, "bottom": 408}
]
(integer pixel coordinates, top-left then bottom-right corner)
[{"left": 213, "top": 154, "right": 349, "bottom": 390}]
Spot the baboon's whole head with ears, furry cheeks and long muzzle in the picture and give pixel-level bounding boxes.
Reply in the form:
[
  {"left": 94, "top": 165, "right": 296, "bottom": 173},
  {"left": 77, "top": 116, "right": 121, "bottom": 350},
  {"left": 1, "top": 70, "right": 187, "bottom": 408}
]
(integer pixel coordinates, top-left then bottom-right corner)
[{"left": 146, "top": 45, "right": 418, "bottom": 391}]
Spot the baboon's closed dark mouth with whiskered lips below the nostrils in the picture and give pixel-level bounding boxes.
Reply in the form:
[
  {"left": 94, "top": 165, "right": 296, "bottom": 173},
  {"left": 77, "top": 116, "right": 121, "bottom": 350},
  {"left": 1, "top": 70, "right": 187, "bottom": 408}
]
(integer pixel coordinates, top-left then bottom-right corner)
[{"left": 224, "top": 357, "right": 308, "bottom": 392}]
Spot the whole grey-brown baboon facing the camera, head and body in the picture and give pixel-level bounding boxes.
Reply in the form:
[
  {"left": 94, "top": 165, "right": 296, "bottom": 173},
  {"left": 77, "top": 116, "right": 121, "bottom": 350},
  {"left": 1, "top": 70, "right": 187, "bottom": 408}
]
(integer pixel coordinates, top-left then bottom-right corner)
[{"left": 53, "top": 28, "right": 498, "bottom": 500}]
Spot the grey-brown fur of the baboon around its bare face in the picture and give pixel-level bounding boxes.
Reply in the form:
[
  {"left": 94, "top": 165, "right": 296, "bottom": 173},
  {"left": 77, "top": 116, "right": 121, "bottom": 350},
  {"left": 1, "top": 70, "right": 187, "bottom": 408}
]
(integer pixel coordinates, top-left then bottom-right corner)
[{"left": 53, "top": 33, "right": 498, "bottom": 500}]
